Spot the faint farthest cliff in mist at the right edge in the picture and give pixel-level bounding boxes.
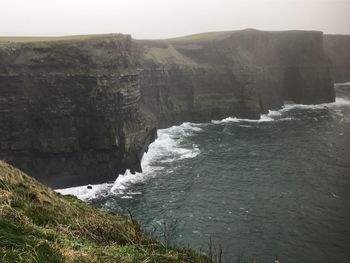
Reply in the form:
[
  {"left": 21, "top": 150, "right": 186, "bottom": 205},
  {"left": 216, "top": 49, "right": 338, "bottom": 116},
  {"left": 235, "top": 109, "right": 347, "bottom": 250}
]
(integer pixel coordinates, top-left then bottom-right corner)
[{"left": 324, "top": 35, "right": 350, "bottom": 83}]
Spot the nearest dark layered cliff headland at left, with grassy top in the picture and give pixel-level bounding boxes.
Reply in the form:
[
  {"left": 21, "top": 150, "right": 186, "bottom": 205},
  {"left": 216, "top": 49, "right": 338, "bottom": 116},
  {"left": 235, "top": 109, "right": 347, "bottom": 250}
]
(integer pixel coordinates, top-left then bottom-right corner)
[{"left": 0, "top": 35, "right": 156, "bottom": 187}]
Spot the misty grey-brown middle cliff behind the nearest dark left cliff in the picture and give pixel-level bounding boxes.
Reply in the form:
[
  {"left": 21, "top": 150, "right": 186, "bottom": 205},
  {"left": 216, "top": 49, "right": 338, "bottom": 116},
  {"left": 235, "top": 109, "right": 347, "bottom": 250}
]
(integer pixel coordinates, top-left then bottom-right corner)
[{"left": 139, "top": 30, "right": 334, "bottom": 127}]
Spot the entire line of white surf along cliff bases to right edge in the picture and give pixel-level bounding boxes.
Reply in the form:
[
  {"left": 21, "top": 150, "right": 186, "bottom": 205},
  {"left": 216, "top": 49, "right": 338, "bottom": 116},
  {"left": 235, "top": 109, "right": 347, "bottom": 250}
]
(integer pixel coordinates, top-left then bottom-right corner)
[{"left": 56, "top": 97, "right": 350, "bottom": 200}]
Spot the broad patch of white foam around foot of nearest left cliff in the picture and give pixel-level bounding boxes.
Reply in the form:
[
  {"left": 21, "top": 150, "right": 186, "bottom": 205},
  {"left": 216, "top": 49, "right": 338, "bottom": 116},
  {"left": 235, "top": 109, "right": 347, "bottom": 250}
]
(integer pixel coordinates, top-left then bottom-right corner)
[{"left": 55, "top": 122, "right": 202, "bottom": 201}]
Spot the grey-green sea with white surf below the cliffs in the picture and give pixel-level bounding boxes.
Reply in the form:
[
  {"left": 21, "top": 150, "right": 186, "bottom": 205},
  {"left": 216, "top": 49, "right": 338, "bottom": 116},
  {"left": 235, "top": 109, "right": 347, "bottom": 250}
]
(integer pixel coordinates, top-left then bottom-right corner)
[{"left": 59, "top": 83, "right": 350, "bottom": 263}]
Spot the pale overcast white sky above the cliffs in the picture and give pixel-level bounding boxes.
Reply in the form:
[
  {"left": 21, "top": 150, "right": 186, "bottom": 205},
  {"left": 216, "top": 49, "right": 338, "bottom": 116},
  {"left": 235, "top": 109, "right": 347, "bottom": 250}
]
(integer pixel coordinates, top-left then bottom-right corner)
[{"left": 0, "top": 0, "right": 350, "bottom": 39}]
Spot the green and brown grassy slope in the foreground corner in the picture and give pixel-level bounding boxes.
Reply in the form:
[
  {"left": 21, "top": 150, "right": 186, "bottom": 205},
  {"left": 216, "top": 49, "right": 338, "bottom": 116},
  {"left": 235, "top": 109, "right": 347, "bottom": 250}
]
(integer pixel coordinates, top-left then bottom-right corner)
[{"left": 0, "top": 161, "right": 210, "bottom": 263}]
